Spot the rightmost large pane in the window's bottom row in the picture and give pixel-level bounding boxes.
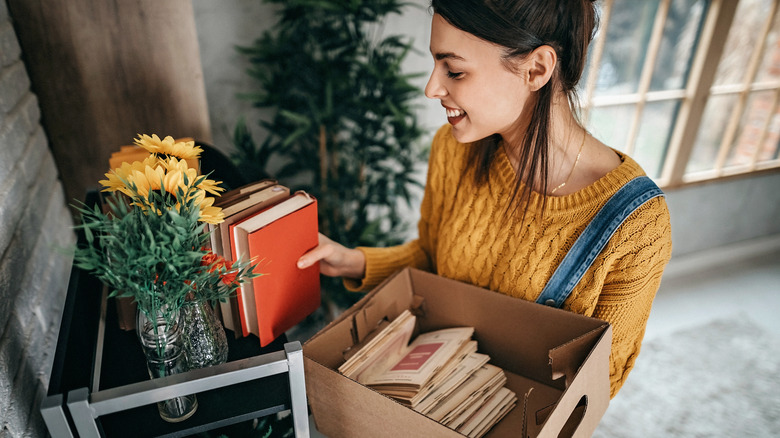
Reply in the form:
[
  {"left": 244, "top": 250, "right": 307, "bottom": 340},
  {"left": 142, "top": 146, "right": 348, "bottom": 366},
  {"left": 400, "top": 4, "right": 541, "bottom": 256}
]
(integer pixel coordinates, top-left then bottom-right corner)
[{"left": 726, "top": 91, "right": 775, "bottom": 166}]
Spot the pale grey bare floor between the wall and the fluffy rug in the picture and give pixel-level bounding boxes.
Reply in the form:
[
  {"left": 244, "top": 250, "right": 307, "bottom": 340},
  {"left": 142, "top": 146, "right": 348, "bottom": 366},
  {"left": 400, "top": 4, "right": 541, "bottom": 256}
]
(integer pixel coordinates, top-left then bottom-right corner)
[{"left": 310, "top": 236, "right": 780, "bottom": 438}]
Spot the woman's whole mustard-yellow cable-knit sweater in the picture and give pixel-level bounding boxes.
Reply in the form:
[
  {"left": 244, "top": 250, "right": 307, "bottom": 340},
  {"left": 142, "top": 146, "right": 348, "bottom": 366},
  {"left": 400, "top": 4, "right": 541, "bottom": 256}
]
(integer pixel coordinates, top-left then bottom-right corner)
[{"left": 345, "top": 125, "right": 672, "bottom": 397}]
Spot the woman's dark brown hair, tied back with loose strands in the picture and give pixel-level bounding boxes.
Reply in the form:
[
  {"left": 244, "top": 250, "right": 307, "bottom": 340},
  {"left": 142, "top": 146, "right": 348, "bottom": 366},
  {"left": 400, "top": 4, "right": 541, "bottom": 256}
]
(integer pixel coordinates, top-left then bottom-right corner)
[{"left": 431, "top": 0, "right": 597, "bottom": 217}]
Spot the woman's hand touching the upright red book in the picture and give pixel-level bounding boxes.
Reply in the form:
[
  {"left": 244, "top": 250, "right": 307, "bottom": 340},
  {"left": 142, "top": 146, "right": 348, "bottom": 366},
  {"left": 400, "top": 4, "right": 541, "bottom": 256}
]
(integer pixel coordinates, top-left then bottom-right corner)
[{"left": 298, "top": 233, "right": 366, "bottom": 278}]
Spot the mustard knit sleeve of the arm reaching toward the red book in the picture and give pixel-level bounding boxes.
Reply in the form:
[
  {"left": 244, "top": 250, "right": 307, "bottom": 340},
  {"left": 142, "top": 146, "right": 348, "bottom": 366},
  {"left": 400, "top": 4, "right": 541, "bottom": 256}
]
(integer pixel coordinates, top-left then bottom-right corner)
[{"left": 344, "top": 125, "right": 451, "bottom": 291}]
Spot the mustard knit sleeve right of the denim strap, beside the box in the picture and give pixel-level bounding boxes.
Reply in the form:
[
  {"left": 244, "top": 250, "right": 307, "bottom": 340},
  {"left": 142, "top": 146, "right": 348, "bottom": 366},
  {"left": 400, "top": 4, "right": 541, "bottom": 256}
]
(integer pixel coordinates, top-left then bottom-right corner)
[{"left": 593, "top": 198, "right": 672, "bottom": 397}]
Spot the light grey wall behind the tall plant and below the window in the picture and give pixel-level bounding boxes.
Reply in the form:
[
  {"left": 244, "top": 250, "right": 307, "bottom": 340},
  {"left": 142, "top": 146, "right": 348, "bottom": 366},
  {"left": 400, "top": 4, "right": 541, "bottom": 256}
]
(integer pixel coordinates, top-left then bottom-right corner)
[{"left": 193, "top": 0, "right": 780, "bottom": 257}]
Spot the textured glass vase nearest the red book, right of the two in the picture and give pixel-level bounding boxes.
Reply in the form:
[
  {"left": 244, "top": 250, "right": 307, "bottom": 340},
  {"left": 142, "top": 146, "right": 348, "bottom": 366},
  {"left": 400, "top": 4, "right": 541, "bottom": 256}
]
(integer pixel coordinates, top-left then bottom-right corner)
[{"left": 181, "top": 301, "right": 228, "bottom": 369}]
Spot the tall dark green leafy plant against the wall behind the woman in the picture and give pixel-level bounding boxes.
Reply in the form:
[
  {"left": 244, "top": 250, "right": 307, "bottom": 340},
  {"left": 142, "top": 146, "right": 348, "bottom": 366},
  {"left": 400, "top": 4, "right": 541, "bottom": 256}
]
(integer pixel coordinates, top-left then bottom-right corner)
[{"left": 234, "top": 0, "right": 425, "bottom": 314}]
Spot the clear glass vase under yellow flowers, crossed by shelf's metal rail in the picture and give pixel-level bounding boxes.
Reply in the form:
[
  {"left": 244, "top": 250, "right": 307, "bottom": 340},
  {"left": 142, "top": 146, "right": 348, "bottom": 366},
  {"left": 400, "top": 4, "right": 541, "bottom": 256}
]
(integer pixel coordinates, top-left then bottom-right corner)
[{"left": 136, "top": 309, "right": 198, "bottom": 423}]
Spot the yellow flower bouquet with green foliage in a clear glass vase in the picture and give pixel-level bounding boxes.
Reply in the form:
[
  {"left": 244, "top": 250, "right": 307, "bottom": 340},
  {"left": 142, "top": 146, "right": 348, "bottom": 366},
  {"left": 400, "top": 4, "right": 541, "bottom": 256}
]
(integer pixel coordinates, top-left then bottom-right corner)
[{"left": 74, "top": 135, "right": 256, "bottom": 422}]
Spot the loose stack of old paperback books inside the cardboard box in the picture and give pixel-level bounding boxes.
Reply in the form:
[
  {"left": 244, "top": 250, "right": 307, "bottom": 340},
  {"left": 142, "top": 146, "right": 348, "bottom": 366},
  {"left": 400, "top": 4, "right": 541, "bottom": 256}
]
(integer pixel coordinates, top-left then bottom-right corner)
[{"left": 339, "top": 310, "right": 517, "bottom": 437}]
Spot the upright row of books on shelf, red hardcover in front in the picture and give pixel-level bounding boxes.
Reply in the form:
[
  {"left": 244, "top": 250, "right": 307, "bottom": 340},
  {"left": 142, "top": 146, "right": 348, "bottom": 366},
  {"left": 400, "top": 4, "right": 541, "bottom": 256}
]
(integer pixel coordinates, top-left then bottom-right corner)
[{"left": 209, "top": 179, "right": 320, "bottom": 346}]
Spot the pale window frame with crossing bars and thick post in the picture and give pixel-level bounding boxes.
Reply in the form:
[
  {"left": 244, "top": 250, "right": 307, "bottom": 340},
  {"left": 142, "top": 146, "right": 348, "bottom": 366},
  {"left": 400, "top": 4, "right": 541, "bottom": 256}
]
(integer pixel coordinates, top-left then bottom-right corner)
[{"left": 581, "top": 0, "right": 780, "bottom": 188}]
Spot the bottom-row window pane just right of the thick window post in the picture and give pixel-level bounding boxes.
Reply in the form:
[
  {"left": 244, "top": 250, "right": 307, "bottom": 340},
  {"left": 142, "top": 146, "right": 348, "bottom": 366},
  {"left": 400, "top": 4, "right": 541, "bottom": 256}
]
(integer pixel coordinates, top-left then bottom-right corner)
[{"left": 685, "top": 94, "right": 737, "bottom": 173}]
